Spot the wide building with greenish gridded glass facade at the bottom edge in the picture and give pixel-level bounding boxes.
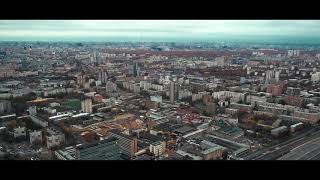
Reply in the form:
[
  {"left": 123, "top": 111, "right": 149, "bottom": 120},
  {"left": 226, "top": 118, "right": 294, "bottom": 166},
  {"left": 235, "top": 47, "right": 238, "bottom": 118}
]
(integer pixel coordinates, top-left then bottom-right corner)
[{"left": 76, "top": 137, "right": 121, "bottom": 160}]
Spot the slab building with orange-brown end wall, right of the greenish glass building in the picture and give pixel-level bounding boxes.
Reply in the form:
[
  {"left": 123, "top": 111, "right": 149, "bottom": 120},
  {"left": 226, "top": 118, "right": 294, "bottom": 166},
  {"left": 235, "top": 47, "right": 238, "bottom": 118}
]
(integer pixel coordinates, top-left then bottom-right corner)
[{"left": 109, "top": 129, "right": 138, "bottom": 159}]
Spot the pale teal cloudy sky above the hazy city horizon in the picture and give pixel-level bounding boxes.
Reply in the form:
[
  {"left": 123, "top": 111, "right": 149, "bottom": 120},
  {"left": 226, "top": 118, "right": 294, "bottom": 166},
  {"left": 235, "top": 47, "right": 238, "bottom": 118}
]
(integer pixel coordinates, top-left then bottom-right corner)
[{"left": 0, "top": 20, "right": 320, "bottom": 42}]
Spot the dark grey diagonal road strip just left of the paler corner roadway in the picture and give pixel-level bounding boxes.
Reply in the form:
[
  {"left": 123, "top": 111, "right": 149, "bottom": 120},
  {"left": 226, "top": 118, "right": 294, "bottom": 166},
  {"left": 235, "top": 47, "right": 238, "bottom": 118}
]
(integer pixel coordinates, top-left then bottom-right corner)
[{"left": 244, "top": 127, "right": 320, "bottom": 160}]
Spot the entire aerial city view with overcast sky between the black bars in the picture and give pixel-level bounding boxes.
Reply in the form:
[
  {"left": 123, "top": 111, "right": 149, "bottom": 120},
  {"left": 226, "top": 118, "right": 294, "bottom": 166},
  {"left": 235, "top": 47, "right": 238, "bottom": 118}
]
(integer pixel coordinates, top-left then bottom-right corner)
[{"left": 0, "top": 20, "right": 320, "bottom": 161}]
